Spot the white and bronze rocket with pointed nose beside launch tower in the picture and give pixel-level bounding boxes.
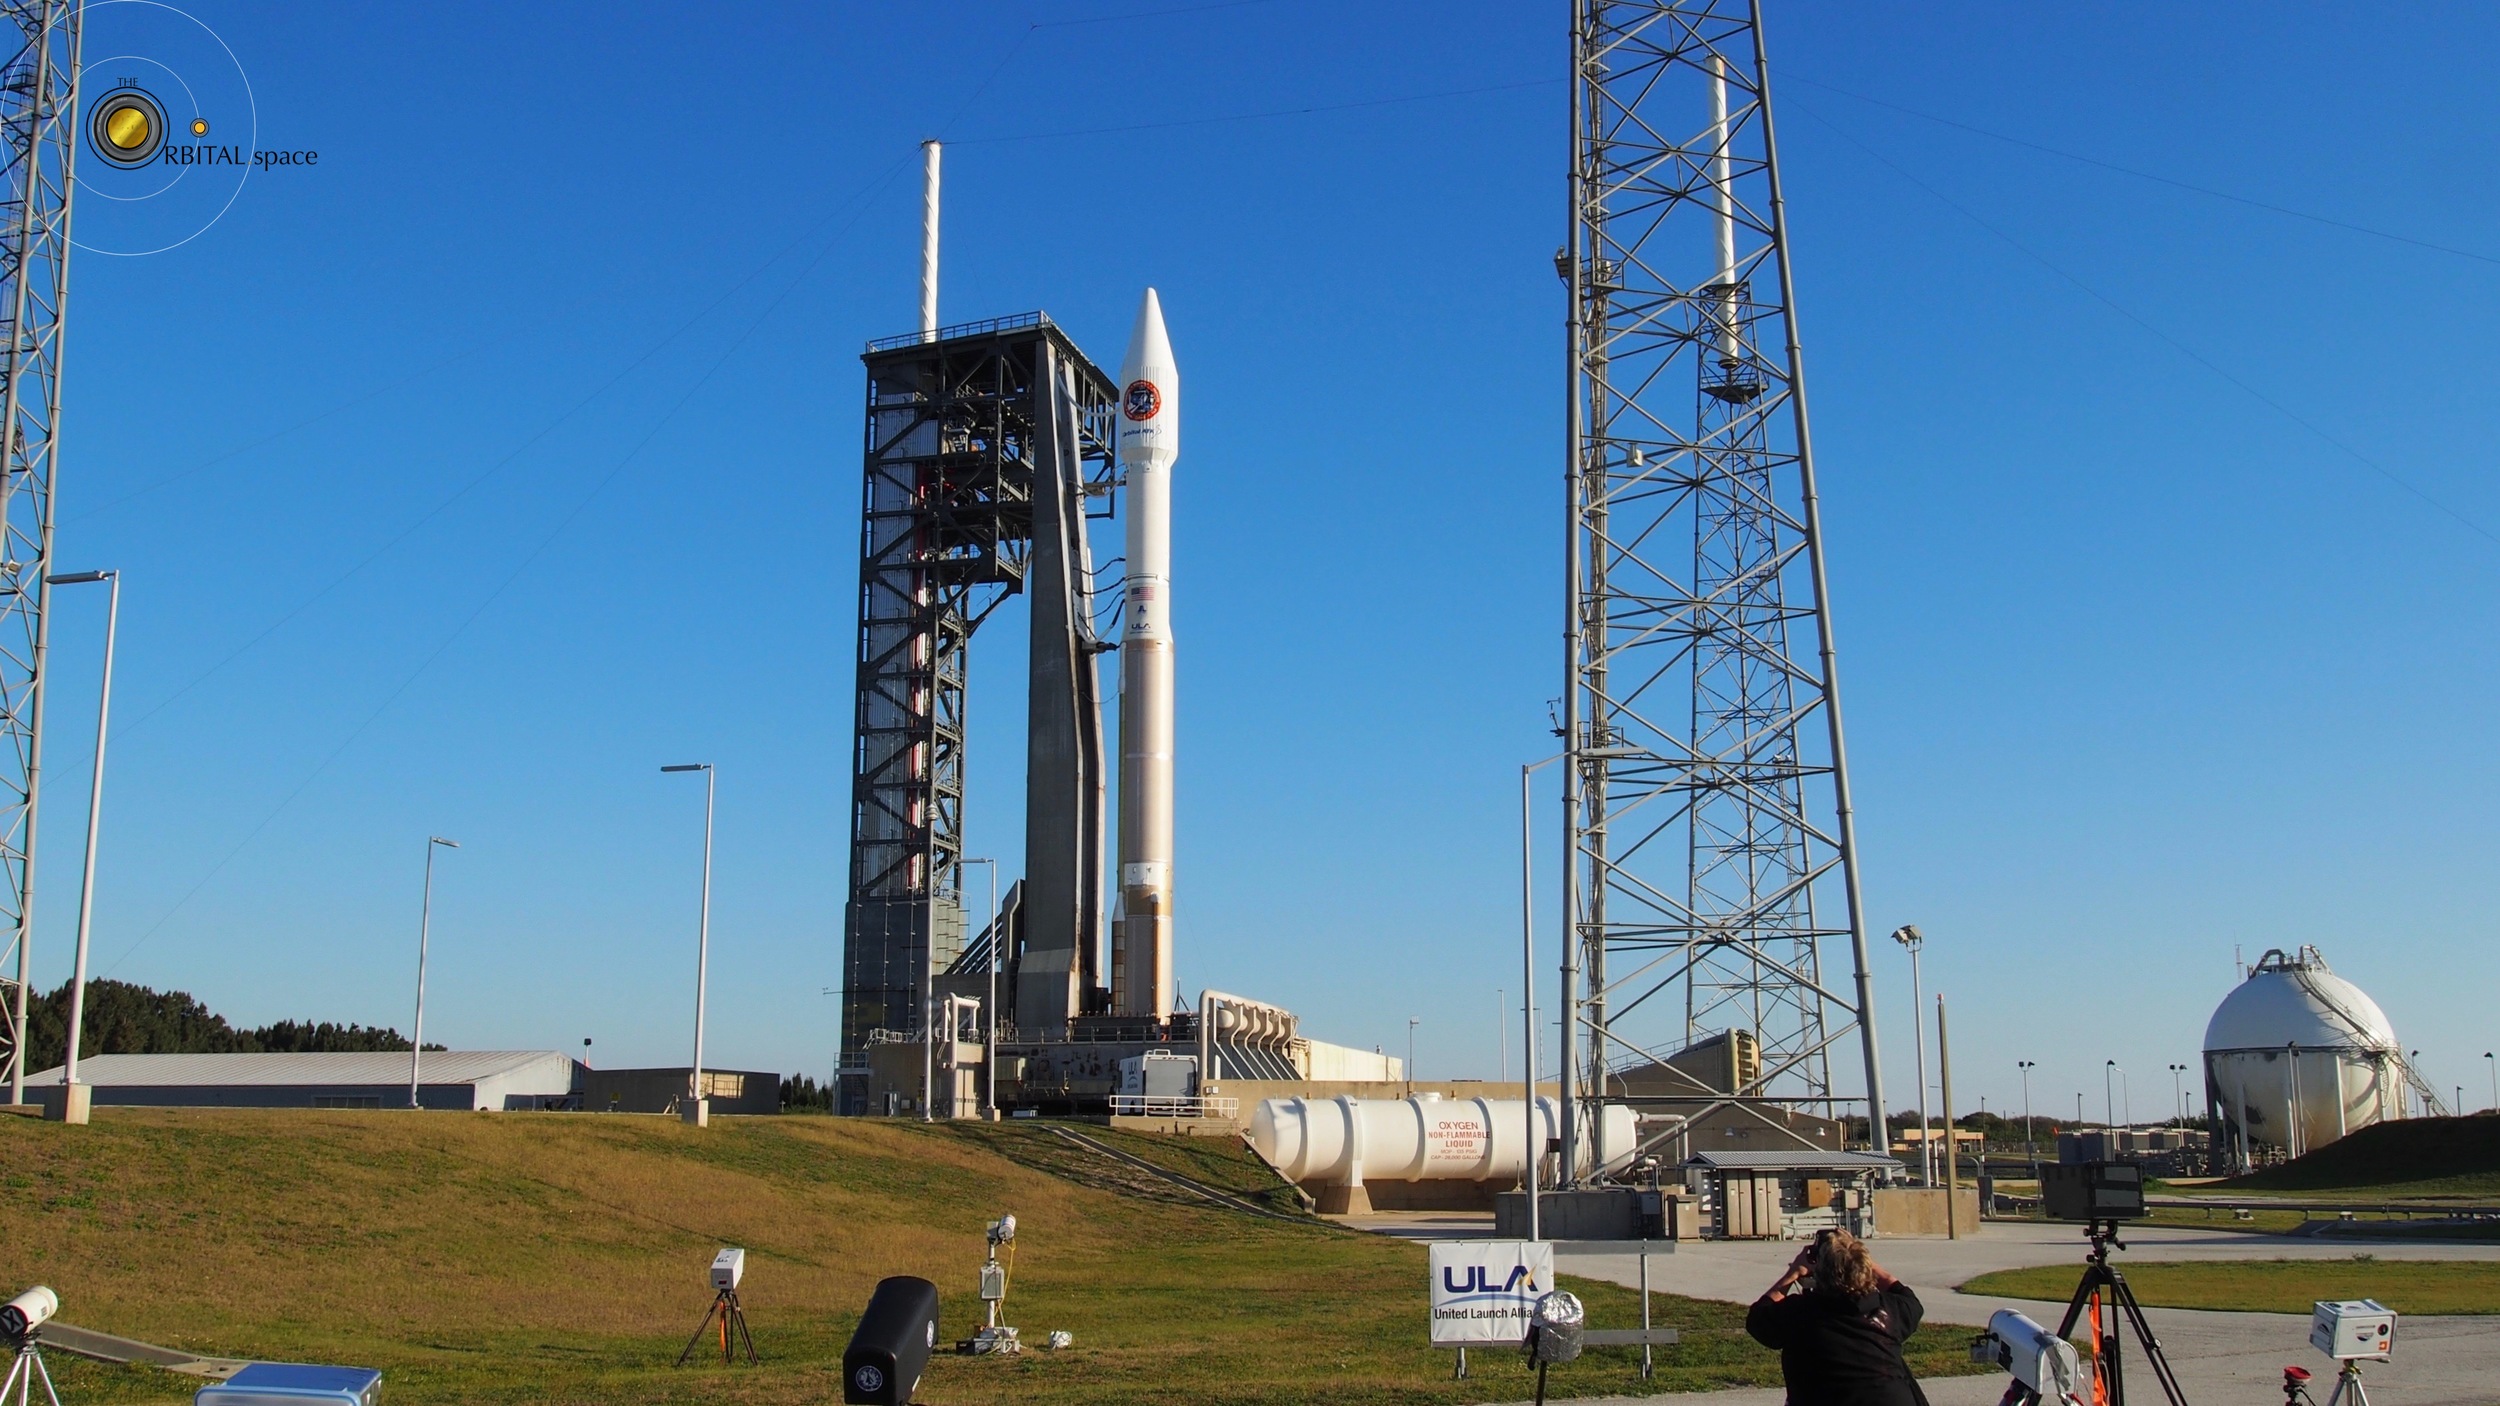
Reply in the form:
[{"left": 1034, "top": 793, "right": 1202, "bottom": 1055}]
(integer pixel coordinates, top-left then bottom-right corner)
[{"left": 1110, "top": 288, "right": 1180, "bottom": 1021}]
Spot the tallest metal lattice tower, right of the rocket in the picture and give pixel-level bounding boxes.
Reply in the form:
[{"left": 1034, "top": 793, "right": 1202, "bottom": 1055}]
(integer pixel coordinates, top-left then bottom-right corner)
[{"left": 1558, "top": 0, "right": 1883, "bottom": 1166}]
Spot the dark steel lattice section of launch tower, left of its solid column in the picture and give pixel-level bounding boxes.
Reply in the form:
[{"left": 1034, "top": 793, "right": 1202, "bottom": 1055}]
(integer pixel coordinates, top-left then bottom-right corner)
[{"left": 840, "top": 313, "right": 1115, "bottom": 1113}]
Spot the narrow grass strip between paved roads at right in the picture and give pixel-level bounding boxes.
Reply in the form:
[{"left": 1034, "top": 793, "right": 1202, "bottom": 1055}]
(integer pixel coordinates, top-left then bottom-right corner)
[{"left": 1960, "top": 1256, "right": 2500, "bottom": 1313}]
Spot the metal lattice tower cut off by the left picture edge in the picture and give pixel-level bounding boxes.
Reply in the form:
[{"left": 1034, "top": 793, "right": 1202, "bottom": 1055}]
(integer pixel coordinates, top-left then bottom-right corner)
[{"left": 0, "top": 0, "right": 85, "bottom": 1103}]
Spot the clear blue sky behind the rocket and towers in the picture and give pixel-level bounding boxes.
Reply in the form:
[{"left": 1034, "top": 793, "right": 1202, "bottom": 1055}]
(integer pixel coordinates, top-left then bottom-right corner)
[{"left": 38, "top": 0, "right": 2500, "bottom": 1116}]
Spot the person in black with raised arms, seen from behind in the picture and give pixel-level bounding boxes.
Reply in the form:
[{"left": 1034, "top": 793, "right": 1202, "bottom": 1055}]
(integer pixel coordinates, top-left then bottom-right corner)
[{"left": 1745, "top": 1231, "right": 1928, "bottom": 1406}]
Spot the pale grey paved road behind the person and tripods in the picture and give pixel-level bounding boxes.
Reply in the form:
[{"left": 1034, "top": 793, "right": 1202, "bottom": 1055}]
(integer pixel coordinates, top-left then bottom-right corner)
[{"left": 1353, "top": 1216, "right": 2500, "bottom": 1406}]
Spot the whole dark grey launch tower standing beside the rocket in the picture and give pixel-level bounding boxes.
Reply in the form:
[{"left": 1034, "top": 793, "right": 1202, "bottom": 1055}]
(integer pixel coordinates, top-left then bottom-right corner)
[{"left": 838, "top": 313, "right": 1118, "bottom": 1113}]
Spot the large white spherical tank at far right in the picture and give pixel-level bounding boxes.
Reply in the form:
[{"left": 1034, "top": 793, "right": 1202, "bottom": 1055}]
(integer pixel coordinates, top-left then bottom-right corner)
[{"left": 2205, "top": 948, "right": 2405, "bottom": 1168}]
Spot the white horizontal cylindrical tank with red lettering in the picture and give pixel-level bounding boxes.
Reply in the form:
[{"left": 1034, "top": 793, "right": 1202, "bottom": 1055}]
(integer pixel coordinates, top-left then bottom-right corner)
[{"left": 1250, "top": 1093, "right": 1638, "bottom": 1186}]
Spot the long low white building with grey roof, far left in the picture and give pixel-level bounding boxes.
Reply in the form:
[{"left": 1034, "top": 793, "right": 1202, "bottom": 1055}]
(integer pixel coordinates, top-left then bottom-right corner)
[{"left": 25, "top": 1051, "right": 583, "bottom": 1111}]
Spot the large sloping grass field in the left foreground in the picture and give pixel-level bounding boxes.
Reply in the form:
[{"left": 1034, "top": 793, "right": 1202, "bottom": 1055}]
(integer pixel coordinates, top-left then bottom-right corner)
[{"left": 0, "top": 1108, "right": 1968, "bottom": 1406}]
